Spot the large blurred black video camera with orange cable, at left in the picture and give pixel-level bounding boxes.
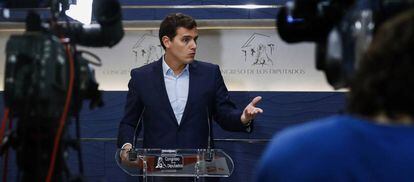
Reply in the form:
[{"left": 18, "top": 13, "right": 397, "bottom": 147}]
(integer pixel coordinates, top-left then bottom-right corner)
[{"left": 0, "top": 0, "right": 124, "bottom": 181}]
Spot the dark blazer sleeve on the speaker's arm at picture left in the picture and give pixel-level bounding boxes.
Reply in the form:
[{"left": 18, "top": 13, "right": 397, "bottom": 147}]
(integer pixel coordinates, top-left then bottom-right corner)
[{"left": 117, "top": 70, "right": 143, "bottom": 148}]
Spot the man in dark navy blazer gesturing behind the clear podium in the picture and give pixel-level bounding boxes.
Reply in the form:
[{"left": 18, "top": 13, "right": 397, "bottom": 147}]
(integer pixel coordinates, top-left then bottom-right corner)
[{"left": 118, "top": 13, "right": 263, "bottom": 161}]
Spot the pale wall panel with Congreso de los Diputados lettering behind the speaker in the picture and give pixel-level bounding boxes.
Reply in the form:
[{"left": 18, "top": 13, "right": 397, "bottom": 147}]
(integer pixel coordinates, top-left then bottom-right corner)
[{"left": 0, "top": 28, "right": 332, "bottom": 91}]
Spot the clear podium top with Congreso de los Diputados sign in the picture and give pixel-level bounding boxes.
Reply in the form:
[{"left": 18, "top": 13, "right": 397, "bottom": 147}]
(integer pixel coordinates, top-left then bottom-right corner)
[{"left": 115, "top": 149, "right": 234, "bottom": 181}]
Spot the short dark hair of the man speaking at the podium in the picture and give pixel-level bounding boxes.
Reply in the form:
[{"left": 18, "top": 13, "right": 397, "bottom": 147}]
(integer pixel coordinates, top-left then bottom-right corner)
[{"left": 158, "top": 13, "right": 197, "bottom": 49}]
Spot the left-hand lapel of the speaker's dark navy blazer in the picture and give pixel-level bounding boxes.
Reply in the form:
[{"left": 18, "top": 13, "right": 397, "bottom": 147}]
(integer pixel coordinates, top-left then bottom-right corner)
[{"left": 153, "top": 58, "right": 178, "bottom": 127}]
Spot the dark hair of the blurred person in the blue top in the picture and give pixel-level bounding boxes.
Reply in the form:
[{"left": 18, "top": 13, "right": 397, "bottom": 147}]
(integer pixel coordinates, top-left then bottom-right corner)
[{"left": 348, "top": 9, "right": 414, "bottom": 119}]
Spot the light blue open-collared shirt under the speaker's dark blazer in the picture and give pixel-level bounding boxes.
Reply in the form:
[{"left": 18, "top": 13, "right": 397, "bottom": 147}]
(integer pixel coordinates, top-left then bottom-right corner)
[{"left": 162, "top": 57, "right": 190, "bottom": 125}]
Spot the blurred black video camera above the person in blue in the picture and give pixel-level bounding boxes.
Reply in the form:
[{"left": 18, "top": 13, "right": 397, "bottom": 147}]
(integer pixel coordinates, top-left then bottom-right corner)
[{"left": 277, "top": 0, "right": 414, "bottom": 89}]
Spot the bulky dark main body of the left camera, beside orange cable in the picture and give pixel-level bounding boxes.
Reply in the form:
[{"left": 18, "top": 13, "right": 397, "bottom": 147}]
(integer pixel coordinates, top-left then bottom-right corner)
[{"left": 4, "top": 32, "right": 69, "bottom": 118}]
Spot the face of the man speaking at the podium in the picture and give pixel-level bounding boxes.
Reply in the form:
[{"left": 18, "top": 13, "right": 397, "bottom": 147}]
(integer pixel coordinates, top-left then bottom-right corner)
[{"left": 164, "top": 27, "right": 198, "bottom": 64}]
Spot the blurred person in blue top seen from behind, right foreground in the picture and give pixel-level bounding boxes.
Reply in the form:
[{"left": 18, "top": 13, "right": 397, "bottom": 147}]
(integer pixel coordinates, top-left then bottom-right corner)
[{"left": 256, "top": 10, "right": 414, "bottom": 182}]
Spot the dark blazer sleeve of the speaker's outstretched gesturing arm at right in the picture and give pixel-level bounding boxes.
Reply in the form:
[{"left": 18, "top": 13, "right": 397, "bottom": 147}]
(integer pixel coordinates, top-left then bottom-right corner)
[{"left": 214, "top": 65, "right": 251, "bottom": 132}]
